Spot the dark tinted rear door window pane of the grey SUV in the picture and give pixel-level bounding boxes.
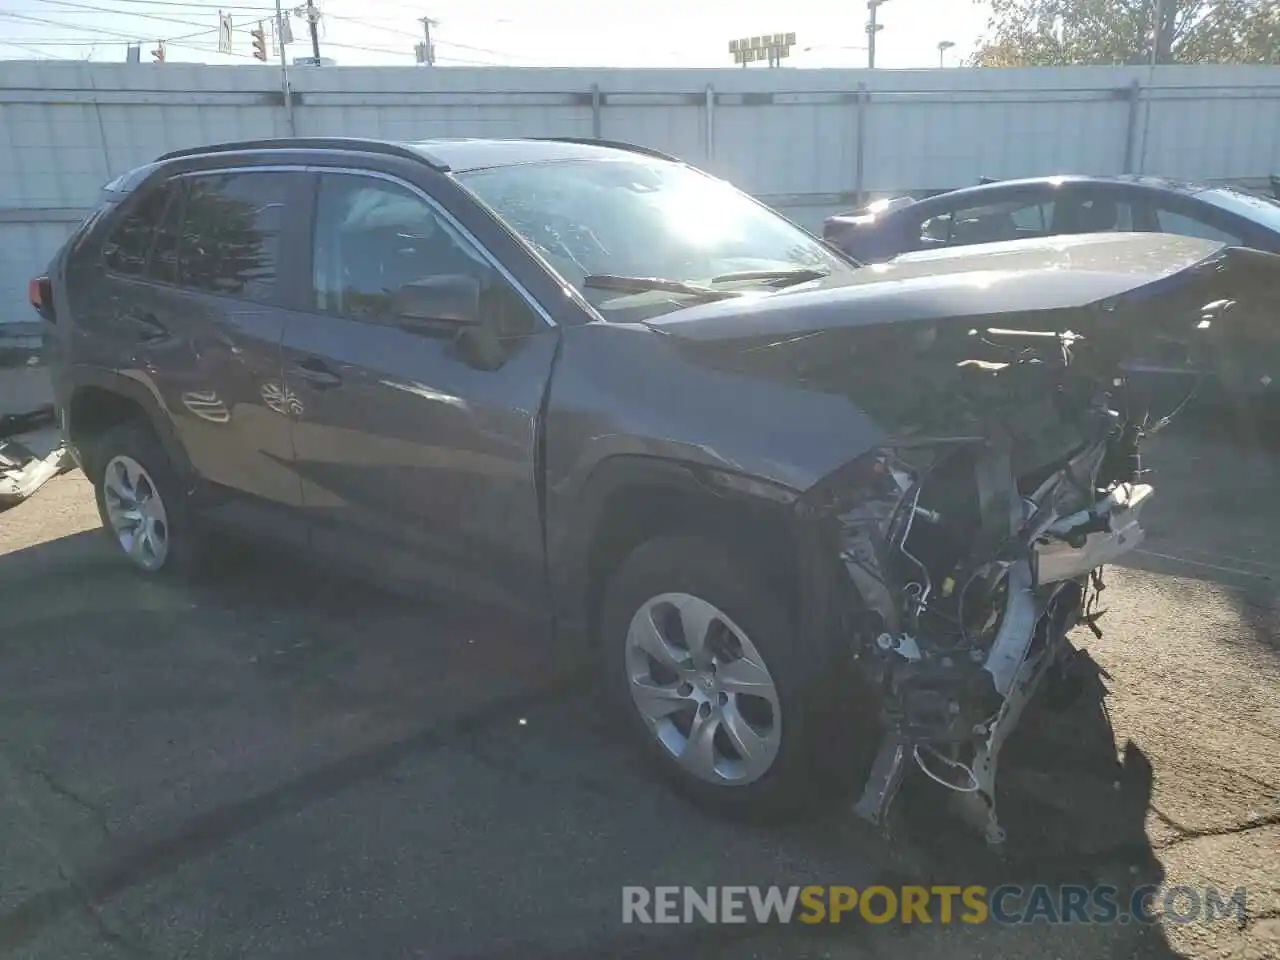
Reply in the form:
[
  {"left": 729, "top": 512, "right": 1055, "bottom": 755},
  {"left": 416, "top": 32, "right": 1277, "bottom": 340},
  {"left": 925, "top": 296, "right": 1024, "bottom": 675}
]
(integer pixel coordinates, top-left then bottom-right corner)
[{"left": 178, "top": 170, "right": 291, "bottom": 302}]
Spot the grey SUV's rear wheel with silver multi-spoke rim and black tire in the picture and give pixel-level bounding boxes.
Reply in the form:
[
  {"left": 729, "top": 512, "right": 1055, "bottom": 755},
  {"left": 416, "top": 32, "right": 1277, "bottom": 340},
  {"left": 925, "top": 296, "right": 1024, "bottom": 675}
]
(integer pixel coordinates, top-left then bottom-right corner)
[{"left": 84, "top": 421, "right": 206, "bottom": 579}]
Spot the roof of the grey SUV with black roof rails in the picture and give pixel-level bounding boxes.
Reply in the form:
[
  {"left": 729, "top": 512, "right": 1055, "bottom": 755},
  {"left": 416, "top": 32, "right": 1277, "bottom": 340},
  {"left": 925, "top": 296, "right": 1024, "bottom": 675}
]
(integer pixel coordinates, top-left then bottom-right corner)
[{"left": 160, "top": 137, "right": 676, "bottom": 172}]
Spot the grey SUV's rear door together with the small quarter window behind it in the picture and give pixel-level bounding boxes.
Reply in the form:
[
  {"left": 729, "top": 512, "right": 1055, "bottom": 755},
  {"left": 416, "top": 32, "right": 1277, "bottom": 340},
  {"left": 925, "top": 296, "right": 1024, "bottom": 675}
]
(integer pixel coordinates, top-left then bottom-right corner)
[{"left": 100, "top": 170, "right": 306, "bottom": 539}]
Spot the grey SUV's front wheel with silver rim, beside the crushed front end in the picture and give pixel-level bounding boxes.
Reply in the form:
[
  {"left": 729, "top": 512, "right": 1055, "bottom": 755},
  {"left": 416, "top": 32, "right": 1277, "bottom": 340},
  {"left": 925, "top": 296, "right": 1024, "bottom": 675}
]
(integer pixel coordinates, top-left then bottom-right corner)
[{"left": 600, "top": 536, "right": 832, "bottom": 817}]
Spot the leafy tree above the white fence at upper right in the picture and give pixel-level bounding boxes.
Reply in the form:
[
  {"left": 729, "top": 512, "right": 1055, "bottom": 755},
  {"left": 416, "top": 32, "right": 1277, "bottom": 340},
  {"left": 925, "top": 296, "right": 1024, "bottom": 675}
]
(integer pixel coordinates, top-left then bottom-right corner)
[{"left": 970, "top": 0, "right": 1280, "bottom": 67}]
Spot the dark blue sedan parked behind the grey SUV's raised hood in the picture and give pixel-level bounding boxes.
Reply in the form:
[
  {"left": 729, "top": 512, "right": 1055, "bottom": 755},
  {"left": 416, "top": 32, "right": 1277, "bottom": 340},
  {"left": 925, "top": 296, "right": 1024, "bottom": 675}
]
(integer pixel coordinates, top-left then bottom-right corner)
[{"left": 823, "top": 177, "right": 1280, "bottom": 262}]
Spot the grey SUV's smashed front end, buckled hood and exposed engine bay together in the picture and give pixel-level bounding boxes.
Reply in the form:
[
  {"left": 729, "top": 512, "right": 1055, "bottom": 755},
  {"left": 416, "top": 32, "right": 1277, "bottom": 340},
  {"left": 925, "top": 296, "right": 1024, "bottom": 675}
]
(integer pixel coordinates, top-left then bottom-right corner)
[{"left": 653, "top": 234, "right": 1280, "bottom": 844}]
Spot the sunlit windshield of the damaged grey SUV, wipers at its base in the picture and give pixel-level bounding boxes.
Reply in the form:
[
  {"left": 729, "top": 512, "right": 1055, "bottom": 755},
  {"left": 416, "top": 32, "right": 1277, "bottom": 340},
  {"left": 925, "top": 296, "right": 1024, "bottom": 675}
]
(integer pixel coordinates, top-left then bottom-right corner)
[{"left": 458, "top": 157, "right": 852, "bottom": 319}]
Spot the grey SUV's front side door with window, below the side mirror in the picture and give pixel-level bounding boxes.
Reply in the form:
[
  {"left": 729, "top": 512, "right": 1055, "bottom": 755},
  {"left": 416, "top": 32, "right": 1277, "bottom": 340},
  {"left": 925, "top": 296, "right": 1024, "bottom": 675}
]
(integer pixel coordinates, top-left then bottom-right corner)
[{"left": 284, "top": 170, "right": 557, "bottom": 609}]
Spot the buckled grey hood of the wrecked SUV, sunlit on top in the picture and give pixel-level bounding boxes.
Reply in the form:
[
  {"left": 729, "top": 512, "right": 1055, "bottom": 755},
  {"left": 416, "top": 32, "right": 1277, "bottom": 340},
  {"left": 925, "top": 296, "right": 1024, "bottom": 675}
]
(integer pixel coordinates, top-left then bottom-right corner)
[{"left": 648, "top": 233, "right": 1244, "bottom": 340}]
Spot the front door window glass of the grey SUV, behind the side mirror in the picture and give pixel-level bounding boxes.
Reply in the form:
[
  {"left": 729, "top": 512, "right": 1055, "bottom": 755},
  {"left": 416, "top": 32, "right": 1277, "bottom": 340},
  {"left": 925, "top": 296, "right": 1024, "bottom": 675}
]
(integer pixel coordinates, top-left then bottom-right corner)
[{"left": 312, "top": 175, "right": 541, "bottom": 334}]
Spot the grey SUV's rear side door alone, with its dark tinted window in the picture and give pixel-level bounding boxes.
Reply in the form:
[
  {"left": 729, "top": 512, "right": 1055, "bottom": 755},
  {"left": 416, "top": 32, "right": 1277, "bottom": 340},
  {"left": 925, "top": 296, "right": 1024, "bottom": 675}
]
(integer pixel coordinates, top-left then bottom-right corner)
[{"left": 152, "top": 168, "right": 306, "bottom": 540}]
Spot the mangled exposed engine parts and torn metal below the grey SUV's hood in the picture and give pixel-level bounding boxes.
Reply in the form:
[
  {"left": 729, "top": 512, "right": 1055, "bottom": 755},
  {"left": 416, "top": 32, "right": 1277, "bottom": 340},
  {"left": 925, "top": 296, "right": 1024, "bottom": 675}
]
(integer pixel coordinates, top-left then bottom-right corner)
[{"left": 840, "top": 329, "right": 1172, "bottom": 844}]
